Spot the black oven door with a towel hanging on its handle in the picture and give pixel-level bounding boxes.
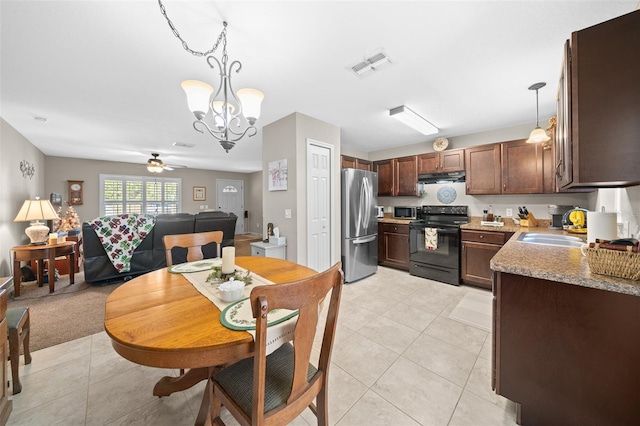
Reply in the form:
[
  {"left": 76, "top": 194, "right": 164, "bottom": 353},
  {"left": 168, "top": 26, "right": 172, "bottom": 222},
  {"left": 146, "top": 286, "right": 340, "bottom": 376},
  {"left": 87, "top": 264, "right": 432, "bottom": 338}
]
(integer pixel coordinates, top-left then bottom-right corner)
[{"left": 409, "top": 224, "right": 460, "bottom": 269}]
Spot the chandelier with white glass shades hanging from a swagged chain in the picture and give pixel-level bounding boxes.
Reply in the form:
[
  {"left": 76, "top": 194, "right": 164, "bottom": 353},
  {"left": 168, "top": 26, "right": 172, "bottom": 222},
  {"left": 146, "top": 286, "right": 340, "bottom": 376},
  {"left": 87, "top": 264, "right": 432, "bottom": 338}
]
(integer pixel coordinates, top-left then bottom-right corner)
[{"left": 158, "top": 0, "right": 264, "bottom": 152}]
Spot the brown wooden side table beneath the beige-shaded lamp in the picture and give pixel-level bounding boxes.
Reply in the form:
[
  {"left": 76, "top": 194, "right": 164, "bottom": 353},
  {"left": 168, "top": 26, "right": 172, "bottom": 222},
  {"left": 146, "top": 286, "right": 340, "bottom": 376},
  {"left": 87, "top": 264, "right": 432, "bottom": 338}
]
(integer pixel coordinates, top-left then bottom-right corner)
[{"left": 11, "top": 241, "right": 76, "bottom": 296}]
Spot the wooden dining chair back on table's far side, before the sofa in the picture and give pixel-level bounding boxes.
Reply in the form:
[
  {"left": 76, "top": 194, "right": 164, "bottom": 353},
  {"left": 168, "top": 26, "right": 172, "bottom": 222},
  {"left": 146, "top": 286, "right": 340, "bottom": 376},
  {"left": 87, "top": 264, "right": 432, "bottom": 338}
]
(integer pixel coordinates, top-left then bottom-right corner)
[{"left": 162, "top": 231, "right": 223, "bottom": 266}]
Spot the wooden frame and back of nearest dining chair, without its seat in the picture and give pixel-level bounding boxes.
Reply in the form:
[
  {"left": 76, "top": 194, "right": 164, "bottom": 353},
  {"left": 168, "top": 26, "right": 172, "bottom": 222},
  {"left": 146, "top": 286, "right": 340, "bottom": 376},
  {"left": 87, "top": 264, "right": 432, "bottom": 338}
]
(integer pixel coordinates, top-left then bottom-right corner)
[{"left": 212, "top": 262, "right": 344, "bottom": 425}]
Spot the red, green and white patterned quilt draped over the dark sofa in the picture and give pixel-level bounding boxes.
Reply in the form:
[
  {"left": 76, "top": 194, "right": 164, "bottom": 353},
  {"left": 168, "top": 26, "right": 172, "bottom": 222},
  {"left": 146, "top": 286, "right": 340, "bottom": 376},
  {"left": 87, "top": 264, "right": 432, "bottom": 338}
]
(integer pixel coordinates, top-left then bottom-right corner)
[{"left": 91, "top": 214, "right": 155, "bottom": 272}]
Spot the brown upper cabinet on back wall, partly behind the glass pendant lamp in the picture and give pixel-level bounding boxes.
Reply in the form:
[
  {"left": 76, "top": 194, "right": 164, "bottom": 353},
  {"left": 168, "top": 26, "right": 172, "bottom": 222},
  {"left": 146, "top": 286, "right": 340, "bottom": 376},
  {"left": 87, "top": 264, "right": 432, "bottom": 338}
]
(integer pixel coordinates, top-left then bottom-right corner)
[{"left": 500, "top": 139, "right": 543, "bottom": 194}]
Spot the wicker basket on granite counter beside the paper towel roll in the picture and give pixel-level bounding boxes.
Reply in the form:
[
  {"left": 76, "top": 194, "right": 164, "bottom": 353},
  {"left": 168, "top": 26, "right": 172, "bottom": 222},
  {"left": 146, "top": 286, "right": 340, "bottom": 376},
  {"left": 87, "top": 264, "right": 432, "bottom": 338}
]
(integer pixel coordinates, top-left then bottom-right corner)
[{"left": 586, "top": 248, "right": 640, "bottom": 280}]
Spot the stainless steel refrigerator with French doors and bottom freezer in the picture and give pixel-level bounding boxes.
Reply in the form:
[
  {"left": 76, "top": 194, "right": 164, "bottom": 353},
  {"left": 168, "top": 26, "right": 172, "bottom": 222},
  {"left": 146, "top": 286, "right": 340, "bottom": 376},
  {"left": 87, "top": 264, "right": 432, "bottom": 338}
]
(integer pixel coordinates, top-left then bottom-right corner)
[{"left": 342, "top": 169, "right": 378, "bottom": 282}]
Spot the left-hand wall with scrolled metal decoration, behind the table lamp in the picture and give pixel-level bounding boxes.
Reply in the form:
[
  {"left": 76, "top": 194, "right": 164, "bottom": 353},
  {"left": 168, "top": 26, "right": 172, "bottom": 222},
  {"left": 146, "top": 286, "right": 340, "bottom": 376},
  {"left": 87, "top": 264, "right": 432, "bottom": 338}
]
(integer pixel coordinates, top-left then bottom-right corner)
[{"left": 0, "top": 118, "right": 49, "bottom": 277}]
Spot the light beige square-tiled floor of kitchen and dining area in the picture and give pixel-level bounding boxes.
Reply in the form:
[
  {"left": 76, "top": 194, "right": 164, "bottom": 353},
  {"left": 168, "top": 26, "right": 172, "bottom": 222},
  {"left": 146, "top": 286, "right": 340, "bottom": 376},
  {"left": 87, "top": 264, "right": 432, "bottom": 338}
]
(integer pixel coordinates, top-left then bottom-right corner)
[{"left": 8, "top": 267, "right": 515, "bottom": 426}]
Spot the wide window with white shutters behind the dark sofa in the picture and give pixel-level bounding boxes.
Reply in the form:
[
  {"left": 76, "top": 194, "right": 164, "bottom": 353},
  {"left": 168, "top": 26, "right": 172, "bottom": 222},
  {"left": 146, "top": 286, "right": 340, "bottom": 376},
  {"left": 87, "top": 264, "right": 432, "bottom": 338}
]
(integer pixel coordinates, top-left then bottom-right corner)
[{"left": 100, "top": 175, "right": 182, "bottom": 216}]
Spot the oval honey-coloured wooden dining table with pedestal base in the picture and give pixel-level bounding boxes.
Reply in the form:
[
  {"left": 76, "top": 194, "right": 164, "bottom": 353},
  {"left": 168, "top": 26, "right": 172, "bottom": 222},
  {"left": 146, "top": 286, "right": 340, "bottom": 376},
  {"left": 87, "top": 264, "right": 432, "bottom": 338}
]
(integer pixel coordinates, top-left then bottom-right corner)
[{"left": 104, "top": 256, "right": 317, "bottom": 417}]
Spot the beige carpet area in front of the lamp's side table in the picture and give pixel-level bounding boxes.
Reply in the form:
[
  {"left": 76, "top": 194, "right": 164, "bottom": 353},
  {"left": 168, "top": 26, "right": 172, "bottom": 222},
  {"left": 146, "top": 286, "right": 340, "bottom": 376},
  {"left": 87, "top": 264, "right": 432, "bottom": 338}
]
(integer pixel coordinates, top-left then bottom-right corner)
[{"left": 8, "top": 271, "right": 121, "bottom": 352}]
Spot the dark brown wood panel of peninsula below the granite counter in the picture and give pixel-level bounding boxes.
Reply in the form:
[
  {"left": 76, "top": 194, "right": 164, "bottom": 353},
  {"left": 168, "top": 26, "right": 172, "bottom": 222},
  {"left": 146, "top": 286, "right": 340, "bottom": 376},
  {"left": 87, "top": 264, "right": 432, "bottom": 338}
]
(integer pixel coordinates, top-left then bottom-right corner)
[{"left": 492, "top": 273, "right": 640, "bottom": 426}]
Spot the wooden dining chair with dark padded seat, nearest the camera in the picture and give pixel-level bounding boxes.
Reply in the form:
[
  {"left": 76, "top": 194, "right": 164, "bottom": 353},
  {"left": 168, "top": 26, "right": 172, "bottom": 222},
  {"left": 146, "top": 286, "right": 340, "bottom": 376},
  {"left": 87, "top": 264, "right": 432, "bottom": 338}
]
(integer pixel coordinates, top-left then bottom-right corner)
[{"left": 206, "top": 262, "right": 344, "bottom": 425}]
